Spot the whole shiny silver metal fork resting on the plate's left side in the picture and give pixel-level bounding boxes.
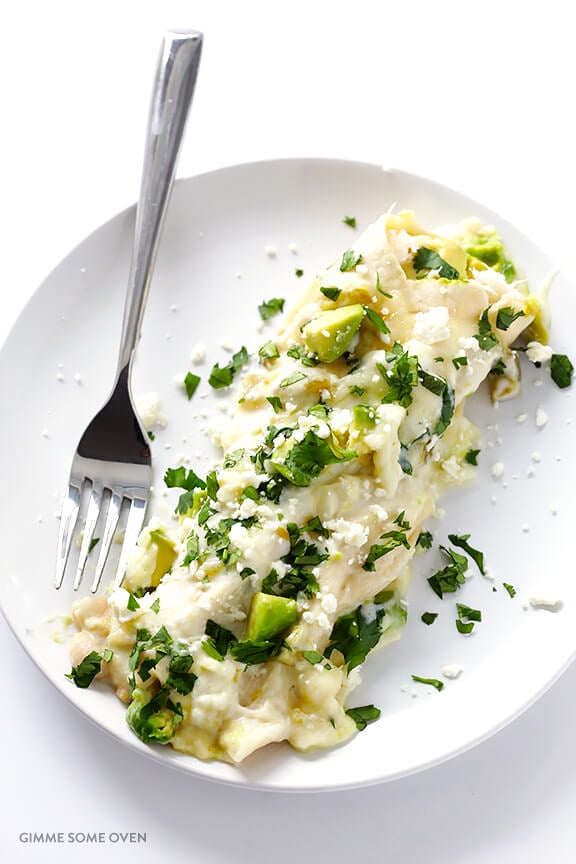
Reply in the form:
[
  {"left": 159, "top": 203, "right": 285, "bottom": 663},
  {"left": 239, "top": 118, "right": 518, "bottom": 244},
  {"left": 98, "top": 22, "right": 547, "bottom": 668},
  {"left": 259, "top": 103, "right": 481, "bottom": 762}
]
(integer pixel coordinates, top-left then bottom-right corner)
[{"left": 55, "top": 31, "right": 202, "bottom": 592}]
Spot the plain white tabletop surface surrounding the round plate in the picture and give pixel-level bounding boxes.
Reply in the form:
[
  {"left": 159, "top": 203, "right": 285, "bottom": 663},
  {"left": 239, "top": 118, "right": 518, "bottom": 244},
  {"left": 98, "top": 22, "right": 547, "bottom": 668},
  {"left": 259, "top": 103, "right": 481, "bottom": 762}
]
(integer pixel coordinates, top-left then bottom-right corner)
[{"left": 0, "top": 0, "right": 576, "bottom": 864}]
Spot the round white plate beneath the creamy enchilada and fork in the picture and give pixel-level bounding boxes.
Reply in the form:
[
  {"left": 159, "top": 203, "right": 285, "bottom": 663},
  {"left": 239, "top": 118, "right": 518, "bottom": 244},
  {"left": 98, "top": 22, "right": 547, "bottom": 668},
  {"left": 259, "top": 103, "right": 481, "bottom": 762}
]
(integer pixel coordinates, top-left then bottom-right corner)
[{"left": 0, "top": 159, "right": 576, "bottom": 790}]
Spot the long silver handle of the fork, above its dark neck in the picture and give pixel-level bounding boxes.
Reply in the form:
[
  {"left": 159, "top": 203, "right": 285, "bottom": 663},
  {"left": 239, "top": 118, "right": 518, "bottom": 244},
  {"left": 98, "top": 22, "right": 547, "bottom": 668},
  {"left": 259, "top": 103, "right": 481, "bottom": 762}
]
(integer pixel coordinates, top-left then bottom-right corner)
[{"left": 117, "top": 31, "right": 202, "bottom": 378}]
